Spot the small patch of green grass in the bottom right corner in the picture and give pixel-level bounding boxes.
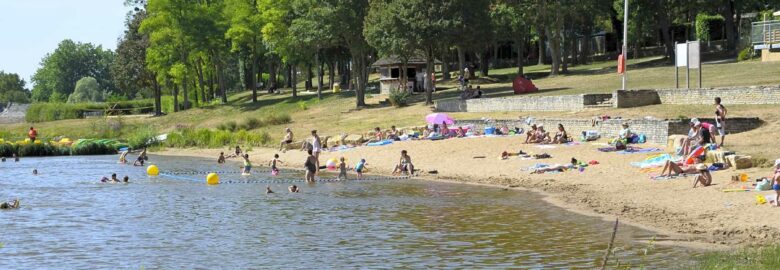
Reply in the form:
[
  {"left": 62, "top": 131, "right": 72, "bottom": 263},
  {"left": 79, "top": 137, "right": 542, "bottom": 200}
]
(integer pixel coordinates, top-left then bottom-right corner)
[{"left": 694, "top": 245, "right": 780, "bottom": 270}]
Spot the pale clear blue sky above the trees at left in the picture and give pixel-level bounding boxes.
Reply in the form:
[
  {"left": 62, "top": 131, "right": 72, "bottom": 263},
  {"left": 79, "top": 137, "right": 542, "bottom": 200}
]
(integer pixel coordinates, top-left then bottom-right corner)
[{"left": 0, "top": 0, "right": 130, "bottom": 88}]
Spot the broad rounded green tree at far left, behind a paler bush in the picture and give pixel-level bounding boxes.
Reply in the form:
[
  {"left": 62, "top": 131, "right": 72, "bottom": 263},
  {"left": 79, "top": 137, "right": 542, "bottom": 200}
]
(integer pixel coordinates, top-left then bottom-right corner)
[{"left": 32, "top": 39, "right": 115, "bottom": 102}]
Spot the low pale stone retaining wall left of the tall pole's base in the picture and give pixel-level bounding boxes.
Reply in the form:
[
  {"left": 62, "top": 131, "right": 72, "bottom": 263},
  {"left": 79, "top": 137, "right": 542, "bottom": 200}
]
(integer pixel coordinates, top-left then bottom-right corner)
[{"left": 435, "top": 94, "right": 612, "bottom": 112}]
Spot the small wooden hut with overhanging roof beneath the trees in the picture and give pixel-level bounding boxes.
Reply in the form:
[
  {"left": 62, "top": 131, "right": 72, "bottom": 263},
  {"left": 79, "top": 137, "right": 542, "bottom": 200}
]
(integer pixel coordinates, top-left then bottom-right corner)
[{"left": 371, "top": 57, "right": 442, "bottom": 94}]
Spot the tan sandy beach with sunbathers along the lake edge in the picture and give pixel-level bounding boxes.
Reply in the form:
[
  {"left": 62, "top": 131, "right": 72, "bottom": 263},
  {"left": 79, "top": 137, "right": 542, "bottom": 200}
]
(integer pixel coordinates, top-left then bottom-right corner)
[{"left": 156, "top": 135, "right": 780, "bottom": 247}]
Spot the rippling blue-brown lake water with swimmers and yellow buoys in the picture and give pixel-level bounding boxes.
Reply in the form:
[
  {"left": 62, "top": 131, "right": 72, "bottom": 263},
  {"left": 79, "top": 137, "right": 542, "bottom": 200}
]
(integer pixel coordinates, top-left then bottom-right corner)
[{"left": 0, "top": 156, "right": 697, "bottom": 269}]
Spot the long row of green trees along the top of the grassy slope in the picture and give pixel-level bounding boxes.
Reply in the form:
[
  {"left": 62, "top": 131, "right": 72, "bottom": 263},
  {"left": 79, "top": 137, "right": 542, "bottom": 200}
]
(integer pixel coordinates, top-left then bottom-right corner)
[{"left": 18, "top": 0, "right": 780, "bottom": 112}]
